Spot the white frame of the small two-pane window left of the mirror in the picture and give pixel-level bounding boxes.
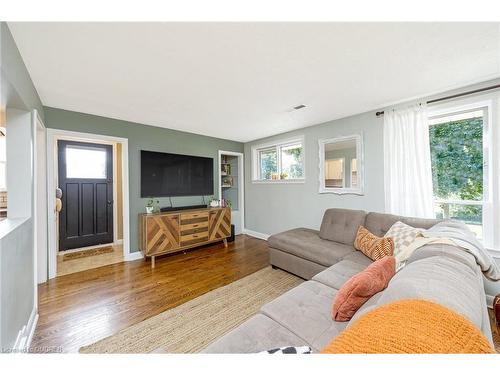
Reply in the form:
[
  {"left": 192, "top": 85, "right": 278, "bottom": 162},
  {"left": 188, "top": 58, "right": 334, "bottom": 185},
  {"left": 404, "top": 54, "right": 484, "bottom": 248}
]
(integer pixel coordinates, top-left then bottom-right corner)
[{"left": 252, "top": 136, "right": 306, "bottom": 184}]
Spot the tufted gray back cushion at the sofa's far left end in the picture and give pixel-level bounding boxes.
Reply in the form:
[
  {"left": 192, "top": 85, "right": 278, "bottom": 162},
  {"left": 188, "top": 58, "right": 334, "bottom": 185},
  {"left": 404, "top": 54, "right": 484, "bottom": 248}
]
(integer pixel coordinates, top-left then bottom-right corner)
[{"left": 319, "top": 208, "right": 366, "bottom": 246}]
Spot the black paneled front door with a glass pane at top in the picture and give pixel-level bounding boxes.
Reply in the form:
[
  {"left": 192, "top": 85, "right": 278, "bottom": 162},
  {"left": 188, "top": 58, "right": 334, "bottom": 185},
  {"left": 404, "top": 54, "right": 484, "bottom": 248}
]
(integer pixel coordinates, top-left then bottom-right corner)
[{"left": 57, "top": 141, "right": 113, "bottom": 251}]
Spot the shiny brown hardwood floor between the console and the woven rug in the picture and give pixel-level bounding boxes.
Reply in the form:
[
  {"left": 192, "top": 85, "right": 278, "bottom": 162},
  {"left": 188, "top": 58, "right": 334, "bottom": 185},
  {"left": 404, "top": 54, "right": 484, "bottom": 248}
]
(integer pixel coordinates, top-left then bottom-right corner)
[{"left": 31, "top": 235, "right": 269, "bottom": 352}]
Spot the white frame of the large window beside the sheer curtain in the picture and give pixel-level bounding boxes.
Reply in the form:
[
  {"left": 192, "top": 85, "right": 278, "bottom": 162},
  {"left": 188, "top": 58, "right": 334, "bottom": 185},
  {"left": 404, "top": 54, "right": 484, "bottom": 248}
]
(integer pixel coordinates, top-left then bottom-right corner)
[{"left": 428, "top": 98, "right": 492, "bottom": 247}]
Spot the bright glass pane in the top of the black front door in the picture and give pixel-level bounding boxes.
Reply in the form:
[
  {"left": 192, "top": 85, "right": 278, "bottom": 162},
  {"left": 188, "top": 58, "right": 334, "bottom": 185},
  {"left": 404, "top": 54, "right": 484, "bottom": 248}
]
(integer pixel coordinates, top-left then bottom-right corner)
[{"left": 66, "top": 146, "right": 106, "bottom": 179}]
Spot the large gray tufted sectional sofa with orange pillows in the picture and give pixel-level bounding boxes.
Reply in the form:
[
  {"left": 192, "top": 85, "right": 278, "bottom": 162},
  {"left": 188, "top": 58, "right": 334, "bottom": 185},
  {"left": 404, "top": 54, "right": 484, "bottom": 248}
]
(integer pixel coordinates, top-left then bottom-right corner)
[{"left": 204, "top": 209, "right": 492, "bottom": 353}]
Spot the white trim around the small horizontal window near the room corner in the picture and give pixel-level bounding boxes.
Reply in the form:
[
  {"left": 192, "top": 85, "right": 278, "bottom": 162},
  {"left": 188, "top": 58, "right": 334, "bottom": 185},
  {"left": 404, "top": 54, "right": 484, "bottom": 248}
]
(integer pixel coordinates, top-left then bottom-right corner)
[{"left": 251, "top": 135, "right": 306, "bottom": 184}]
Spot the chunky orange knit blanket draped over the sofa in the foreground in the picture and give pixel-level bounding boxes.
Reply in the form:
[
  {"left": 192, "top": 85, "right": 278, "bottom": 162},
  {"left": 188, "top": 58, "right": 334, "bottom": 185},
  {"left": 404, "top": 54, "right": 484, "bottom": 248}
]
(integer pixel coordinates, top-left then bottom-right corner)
[{"left": 322, "top": 300, "right": 495, "bottom": 354}]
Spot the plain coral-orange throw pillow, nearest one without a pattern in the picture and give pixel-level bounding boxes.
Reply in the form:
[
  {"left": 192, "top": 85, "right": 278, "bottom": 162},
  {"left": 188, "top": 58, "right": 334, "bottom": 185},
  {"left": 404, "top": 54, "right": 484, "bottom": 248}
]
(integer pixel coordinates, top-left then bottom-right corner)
[{"left": 332, "top": 256, "right": 396, "bottom": 322}]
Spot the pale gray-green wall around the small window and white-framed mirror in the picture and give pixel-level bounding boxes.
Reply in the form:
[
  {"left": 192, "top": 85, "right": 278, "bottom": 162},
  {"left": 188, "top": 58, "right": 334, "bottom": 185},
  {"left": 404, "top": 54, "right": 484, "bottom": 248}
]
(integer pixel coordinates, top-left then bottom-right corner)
[{"left": 245, "top": 112, "right": 384, "bottom": 234}]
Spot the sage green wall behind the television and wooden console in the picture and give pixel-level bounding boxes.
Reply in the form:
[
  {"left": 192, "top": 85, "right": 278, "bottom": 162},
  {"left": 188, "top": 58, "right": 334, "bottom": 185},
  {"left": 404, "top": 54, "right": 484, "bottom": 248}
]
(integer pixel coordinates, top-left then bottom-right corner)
[{"left": 44, "top": 107, "right": 243, "bottom": 252}]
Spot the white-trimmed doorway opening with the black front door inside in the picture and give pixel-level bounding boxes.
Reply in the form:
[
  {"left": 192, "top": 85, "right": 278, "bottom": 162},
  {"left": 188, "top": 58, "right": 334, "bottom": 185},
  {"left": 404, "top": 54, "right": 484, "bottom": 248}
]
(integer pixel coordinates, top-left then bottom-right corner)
[{"left": 48, "top": 131, "right": 129, "bottom": 278}]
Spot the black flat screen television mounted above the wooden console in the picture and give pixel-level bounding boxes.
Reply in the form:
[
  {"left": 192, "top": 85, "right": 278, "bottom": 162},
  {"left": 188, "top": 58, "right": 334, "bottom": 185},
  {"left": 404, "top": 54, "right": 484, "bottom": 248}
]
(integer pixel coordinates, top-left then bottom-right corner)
[{"left": 141, "top": 150, "right": 214, "bottom": 198}]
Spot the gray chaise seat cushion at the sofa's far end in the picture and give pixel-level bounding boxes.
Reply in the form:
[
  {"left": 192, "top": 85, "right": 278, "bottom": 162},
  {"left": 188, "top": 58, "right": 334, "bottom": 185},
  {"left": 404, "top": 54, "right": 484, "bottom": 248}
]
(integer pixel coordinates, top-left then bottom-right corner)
[{"left": 267, "top": 228, "right": 356, "bottom": 267}]
